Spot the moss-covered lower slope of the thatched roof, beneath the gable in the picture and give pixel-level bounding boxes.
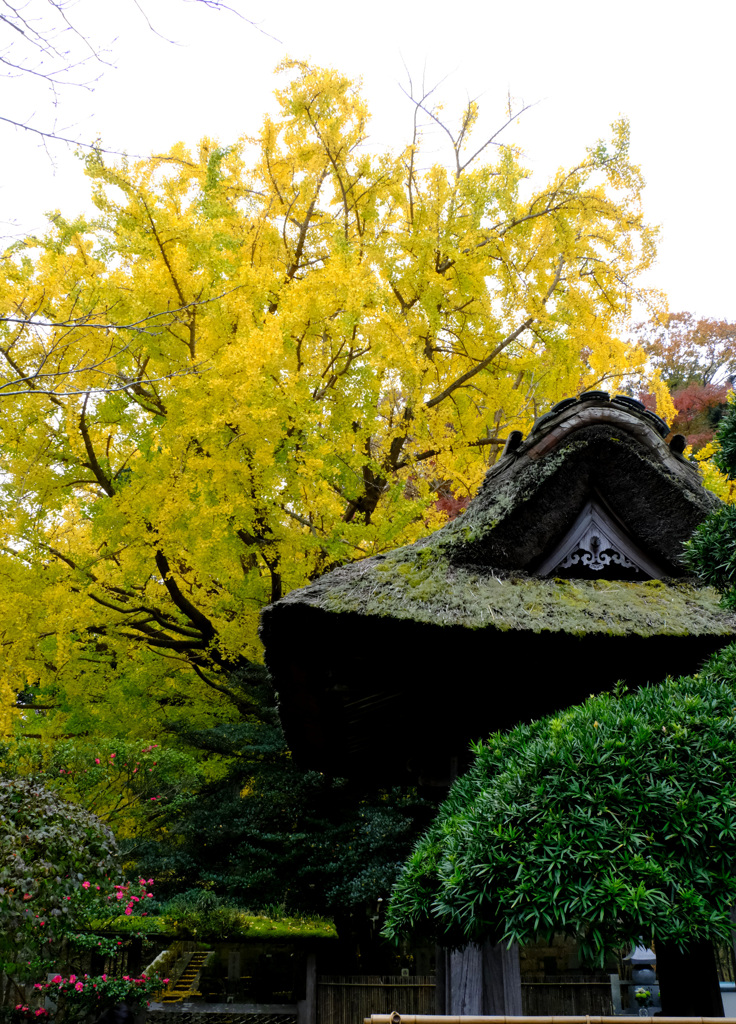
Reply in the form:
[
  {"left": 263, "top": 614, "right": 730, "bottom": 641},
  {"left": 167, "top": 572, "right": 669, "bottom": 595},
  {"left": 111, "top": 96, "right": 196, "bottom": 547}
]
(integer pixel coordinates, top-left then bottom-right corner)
[{"left": 282, "top": 546, "right": 736, "bottom": 637}]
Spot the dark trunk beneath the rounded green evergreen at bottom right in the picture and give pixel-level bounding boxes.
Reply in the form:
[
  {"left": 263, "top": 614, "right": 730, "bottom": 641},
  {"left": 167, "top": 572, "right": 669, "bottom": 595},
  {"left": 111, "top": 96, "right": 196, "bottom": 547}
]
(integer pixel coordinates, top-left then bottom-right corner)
[{"left": 656, "top": 942, "right": 724, "bottom": 1017}]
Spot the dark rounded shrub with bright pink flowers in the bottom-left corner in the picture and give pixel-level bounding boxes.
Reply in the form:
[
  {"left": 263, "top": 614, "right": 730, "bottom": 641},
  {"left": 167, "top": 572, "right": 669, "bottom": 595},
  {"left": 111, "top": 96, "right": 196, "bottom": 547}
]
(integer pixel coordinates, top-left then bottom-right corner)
[{"left": 0, "top": 766, "right": 166, "bottom": 1024}]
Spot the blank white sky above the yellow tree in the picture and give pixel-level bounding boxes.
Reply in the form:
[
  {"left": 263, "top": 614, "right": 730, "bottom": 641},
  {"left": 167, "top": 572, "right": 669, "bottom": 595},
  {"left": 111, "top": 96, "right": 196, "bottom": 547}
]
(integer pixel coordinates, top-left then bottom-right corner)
[{"left": 0, "top": 0, "right": 736, "bottom": 321}]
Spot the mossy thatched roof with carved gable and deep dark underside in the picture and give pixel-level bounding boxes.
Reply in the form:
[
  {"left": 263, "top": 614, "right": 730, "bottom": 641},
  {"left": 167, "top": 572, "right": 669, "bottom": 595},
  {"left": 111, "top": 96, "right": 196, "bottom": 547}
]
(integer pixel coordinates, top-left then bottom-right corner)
[{"left": 262, "top": 392, "right": 736, "bottom": 775}]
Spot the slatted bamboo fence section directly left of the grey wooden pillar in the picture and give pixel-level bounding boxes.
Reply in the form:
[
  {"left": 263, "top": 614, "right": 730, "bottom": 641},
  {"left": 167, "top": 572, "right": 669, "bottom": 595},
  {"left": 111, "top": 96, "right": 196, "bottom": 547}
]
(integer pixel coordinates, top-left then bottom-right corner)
[{"left": 317, "top": 975, "right": 434, "bottom": 1024}]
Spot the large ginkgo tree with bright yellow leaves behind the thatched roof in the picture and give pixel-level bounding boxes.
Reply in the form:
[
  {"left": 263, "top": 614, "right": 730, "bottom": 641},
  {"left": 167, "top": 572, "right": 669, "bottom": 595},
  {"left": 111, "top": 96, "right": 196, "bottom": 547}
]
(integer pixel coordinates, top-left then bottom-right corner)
[{"left": 0, "top": 61, "right": 672, "bottom": 729}]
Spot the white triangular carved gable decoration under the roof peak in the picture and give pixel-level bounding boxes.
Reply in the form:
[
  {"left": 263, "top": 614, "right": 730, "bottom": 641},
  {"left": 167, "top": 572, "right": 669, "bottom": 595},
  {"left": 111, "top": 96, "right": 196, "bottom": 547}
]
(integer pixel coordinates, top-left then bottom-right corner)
[{"left": 536, "top": 499, "right": 665, "bottom": 580}]
